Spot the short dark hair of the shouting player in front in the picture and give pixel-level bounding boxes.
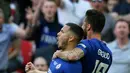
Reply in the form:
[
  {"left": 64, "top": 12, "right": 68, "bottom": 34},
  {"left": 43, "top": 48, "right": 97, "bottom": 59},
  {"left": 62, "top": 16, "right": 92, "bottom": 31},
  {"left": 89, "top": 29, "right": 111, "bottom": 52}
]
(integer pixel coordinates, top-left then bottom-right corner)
[{"left": 66, "top": 23, "right": 84, "bottom": 42}]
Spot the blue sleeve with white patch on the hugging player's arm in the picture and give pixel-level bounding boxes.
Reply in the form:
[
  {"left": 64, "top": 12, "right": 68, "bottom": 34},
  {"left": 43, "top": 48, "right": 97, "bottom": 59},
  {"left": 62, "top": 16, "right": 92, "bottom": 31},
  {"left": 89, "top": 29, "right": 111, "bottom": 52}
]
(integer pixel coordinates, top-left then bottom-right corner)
[{"left": 76, "top": 40, "right": 89, "bottom": 55}]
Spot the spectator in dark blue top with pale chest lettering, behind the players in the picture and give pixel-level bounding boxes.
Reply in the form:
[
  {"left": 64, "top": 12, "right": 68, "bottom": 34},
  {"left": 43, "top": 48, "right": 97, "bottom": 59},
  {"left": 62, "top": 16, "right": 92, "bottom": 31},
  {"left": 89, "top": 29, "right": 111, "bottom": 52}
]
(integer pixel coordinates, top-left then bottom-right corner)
[{"left": 28, "top": 1, "right": 62, "bottom": 48}]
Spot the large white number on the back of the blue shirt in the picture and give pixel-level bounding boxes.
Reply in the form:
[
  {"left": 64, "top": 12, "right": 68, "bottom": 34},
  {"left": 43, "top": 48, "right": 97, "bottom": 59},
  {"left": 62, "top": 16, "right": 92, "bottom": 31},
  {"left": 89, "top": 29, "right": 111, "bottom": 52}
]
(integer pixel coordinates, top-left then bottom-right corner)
[{"left": 92, "top": 60, "right": 109, "bottom": 73}]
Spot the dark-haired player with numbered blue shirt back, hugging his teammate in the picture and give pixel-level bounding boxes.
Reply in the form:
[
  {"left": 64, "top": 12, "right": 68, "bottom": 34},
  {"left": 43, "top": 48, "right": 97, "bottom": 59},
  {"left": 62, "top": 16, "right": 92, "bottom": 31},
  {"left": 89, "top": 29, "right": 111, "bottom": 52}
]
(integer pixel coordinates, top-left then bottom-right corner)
[{"left": 53, "top": 10, "right": 112, "bottom": 73}]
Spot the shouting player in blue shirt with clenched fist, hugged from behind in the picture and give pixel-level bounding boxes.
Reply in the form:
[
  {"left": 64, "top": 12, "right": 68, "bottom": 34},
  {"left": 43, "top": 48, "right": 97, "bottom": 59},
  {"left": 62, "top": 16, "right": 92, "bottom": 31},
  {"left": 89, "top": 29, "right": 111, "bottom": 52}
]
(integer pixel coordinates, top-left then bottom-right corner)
[{"left": 26, "top": 23, "right": 84, "bottom": 73}]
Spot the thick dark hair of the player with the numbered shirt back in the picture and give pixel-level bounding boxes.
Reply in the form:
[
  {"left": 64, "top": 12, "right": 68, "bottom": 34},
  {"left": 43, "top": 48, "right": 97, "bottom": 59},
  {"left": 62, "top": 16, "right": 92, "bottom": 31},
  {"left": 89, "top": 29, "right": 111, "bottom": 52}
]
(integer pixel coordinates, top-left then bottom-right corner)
[{"left": 85, "top": 9, "right": 105, "bottom": 33}]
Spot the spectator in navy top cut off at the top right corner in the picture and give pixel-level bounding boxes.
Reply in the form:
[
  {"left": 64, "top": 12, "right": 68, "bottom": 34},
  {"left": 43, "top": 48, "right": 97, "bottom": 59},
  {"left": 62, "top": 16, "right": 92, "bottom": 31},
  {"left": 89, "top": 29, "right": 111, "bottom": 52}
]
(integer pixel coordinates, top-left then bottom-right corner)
[{"left": 112, "top": 0, "right": 130, "bottom": 21}]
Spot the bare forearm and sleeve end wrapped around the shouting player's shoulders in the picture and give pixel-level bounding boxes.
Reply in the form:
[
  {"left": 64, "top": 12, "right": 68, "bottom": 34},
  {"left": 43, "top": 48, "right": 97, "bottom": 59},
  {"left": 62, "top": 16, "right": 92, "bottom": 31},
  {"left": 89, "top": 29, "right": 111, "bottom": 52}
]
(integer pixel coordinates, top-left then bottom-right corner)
[{"left": 53, "top": 42, "right": 87, "bottom": 61}]
